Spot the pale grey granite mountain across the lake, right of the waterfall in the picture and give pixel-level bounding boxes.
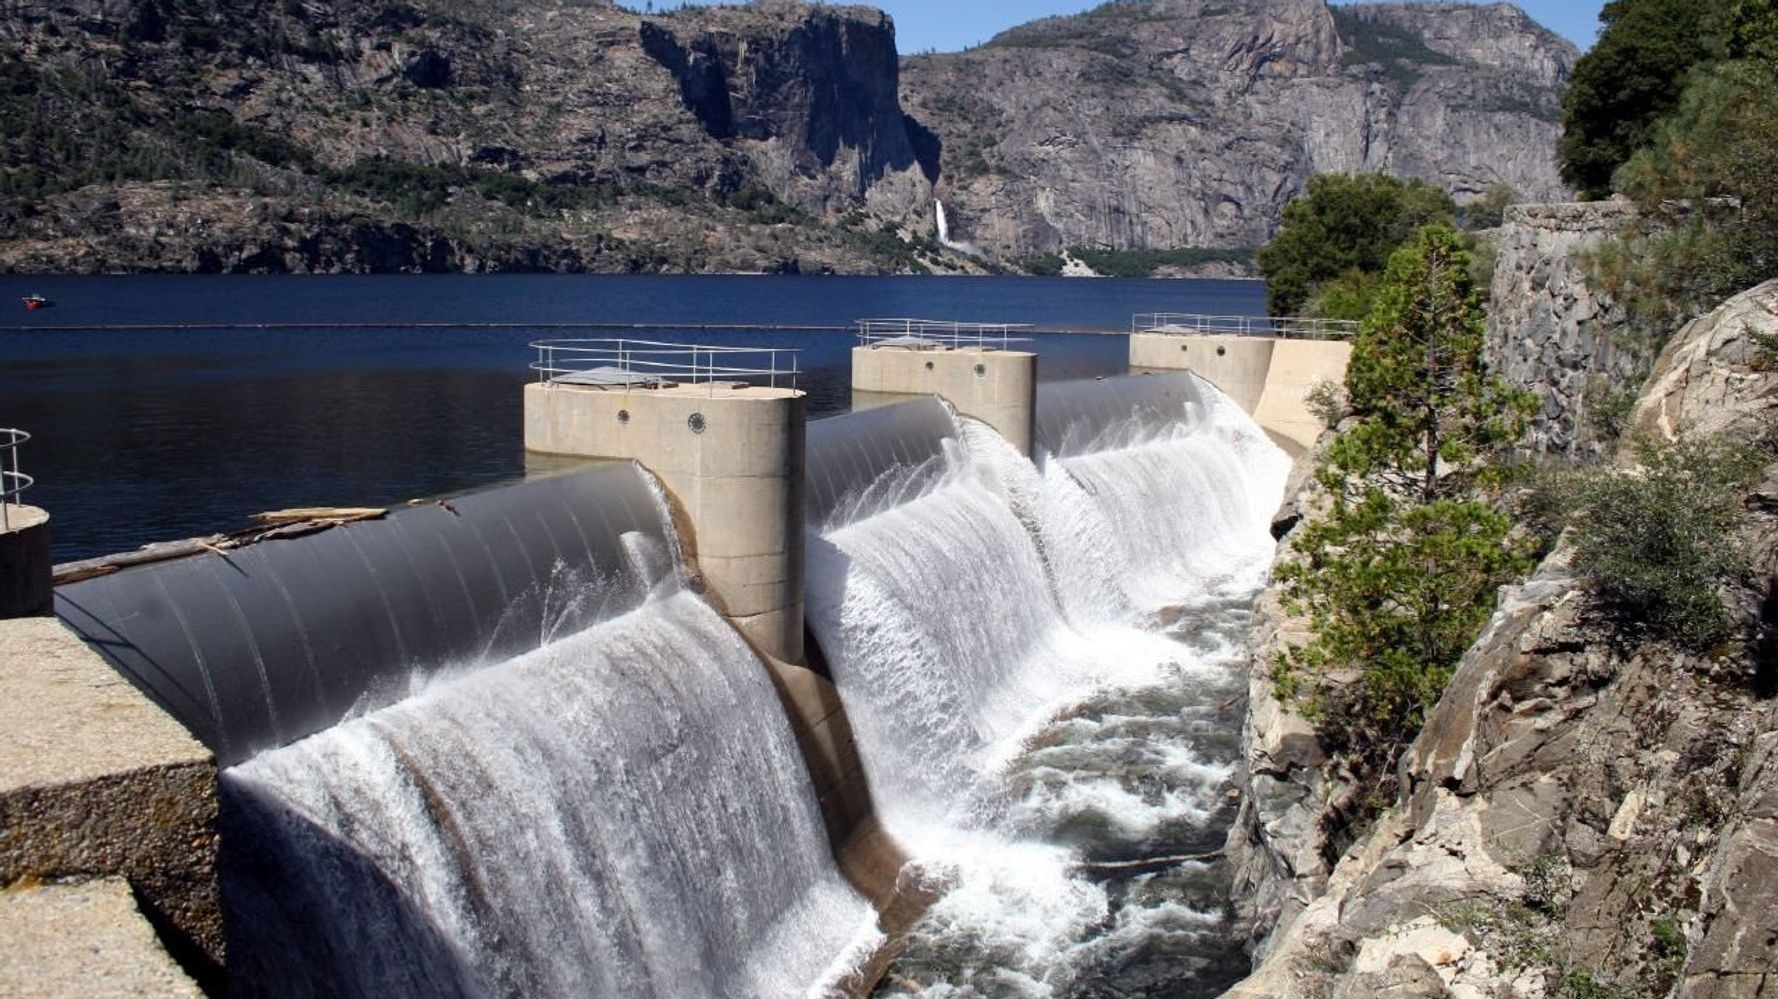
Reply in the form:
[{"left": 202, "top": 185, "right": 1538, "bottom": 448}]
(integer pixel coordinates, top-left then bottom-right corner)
[{"left": 903, "top": 0, "right": 1579, "bottom": 258}]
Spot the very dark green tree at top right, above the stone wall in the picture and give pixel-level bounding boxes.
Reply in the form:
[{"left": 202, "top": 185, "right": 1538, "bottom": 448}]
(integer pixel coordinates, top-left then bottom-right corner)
[{"left": 1556, "top": 0, "right": 1732, "bottom": 197}]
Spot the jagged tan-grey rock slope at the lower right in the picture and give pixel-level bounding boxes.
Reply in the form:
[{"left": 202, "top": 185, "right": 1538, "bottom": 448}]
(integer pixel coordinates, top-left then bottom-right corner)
[{"left": 1229, "top": 283, "right": 1778, "bottom": 999}]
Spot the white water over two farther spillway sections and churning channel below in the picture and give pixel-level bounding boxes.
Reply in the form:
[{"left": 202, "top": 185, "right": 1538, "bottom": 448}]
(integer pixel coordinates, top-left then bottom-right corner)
[{"left": 809, "top": 377, "right": 1289, "bottom": 995}]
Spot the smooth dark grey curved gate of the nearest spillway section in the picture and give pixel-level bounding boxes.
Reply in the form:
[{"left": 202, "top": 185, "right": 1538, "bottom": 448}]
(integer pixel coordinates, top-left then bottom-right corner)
[{"left": 55, "top": 464, "right": 672, "bottom": 766}]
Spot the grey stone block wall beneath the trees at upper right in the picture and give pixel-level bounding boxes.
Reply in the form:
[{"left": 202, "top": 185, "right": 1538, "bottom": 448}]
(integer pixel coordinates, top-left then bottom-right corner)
[{"left": 1486, "top": 201, "right": 1654, "bottom": 459}]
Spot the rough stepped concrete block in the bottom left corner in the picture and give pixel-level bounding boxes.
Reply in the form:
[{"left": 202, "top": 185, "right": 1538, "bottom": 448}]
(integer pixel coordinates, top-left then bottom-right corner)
[{"left": 0, "top": 617, "right": 222, "bottom": 994}]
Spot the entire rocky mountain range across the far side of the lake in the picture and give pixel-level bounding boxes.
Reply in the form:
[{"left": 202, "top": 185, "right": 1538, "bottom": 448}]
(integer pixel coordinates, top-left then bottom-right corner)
[{"left": 0, "top": 0, "right": 1574, "bottom": 272}]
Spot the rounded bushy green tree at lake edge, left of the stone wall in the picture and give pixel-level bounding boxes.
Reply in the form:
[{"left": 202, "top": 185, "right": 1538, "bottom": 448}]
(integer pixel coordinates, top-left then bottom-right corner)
[{"left": 1259, "top": 174, "right": 1456, "bottom": 316}]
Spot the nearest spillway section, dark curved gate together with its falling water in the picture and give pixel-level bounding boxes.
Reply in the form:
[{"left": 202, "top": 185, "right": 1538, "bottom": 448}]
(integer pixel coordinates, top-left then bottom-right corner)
[{"left": 59, "top": 464, "right": 875, "bottom": 997}]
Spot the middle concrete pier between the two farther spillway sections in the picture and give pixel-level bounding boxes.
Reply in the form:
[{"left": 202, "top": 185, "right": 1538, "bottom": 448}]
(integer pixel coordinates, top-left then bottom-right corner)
[{"left": 852, "top": 347, "right": 1037, "bottom": 455}]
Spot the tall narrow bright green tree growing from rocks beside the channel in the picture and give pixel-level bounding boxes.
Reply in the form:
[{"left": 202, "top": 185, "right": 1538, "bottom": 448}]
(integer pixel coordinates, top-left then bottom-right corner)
[{"left": 1275, "top": 226, "right": 1531, "bottom": 784}]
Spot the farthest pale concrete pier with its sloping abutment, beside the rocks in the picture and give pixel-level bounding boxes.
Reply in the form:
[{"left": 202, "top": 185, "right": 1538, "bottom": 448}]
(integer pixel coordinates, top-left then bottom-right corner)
[{"left": 1129, "top": 332, "right": 1351, "bottom": 459}]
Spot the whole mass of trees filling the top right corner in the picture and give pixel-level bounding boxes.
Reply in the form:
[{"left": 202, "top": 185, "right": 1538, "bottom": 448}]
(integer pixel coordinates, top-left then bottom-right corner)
[{"left": 1561, "top": 0, "right": 1778, "bottom": 328}]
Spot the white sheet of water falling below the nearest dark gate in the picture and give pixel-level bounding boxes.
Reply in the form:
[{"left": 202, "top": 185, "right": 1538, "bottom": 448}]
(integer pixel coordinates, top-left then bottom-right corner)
[{"left": 224, "top": 592, "right": 873, "bottom": 997}]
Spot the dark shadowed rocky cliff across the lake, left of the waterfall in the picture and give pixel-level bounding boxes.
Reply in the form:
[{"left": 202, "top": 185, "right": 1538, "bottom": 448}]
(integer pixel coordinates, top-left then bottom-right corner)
[{"left": 0, "top": 0, "right": 962, "bottom": 270}]
